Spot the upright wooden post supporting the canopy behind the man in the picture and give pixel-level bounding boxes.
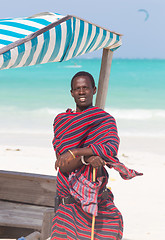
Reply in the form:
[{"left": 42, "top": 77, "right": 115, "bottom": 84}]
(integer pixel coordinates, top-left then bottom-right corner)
[{"left": 95, "top": 48, "right": 113, "bottom": 109}]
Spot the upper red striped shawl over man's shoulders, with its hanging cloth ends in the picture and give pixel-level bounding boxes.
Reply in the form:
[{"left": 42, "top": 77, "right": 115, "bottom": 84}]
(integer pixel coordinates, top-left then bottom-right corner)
[{"left": 53, "top": 107, "right": 141, "bottom": 215}]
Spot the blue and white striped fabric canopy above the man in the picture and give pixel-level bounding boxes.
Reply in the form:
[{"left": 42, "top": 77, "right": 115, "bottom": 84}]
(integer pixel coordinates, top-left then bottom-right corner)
[{"left": 0, "top": 13, "right": 121, "bottom": 69}]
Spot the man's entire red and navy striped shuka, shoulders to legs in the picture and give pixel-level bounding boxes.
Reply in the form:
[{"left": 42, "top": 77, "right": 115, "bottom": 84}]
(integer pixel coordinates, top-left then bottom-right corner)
[{"left": 52, "top": 107, "right": 141, "bottom": 240}]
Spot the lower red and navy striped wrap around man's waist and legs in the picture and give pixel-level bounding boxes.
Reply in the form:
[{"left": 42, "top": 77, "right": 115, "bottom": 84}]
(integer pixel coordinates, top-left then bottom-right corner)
[{"left": 51, "top": 166, "right": 123, "bottom": 240}]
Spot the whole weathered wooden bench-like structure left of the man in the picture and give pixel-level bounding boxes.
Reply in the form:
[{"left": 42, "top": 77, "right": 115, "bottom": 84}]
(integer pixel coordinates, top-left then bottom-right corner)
[{"left": 0, "top": 171, "right": 56, "bottom": 240}]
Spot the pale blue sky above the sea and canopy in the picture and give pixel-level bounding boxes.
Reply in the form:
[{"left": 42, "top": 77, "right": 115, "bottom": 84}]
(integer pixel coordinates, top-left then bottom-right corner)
[{"left": 0, "top": 0, "right": 165, "bottom": 59}]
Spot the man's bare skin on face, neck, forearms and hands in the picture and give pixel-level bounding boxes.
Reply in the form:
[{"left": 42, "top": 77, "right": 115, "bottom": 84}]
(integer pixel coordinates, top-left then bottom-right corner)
[{"left": 55, "top": 76, "right": 105, "bottom": 173}]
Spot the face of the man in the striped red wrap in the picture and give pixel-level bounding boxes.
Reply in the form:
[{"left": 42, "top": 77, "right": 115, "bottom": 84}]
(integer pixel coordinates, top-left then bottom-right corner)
[{"left": 71, "top": 76, "right": 96, "bottom": 112}]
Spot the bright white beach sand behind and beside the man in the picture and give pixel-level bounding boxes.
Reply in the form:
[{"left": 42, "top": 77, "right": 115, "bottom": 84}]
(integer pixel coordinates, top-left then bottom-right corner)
[{"left": 0, "top": 133, "right": 165, "bottom": 240}]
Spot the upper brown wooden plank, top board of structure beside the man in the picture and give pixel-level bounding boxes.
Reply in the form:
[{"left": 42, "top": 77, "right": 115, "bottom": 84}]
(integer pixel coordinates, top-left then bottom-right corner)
[{"left": 0, "top": 171, "right": 56, "bottom": 207}]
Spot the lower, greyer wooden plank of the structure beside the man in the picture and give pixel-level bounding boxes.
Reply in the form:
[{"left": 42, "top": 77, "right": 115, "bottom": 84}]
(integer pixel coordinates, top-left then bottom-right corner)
[{"left": 0, "top": 201, "right": 53, "bottom": 231}]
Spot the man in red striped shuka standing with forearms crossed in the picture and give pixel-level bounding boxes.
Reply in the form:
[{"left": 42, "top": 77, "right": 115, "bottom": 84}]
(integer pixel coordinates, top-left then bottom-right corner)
[{"left": 51, "top": 72, "right": 142, "bottom": 240}]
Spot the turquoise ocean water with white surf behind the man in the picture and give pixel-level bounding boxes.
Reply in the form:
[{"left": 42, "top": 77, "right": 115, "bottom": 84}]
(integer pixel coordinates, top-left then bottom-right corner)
[{"left": 0, "top": 58, "right": 165, "bottom": 137}]
